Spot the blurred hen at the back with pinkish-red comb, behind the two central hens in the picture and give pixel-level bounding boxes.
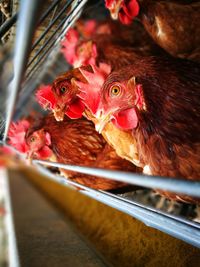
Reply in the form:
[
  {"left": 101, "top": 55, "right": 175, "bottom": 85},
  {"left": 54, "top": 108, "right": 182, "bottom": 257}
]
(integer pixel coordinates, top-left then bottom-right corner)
[{"left": 61, "top": 20, "right": 164, "bottom": 69}]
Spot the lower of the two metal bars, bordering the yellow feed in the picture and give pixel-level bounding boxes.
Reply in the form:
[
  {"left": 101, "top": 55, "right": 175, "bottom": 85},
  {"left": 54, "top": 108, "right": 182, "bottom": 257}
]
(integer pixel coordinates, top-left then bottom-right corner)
[{"left": 33, "top": 166, "right": 200, "bottom": 248}]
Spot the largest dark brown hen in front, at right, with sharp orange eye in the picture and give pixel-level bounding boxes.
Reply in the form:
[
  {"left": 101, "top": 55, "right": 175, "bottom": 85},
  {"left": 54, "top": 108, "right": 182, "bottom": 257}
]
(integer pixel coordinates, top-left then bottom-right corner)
[{"left": 90, "top": 57, "right": 200, "bottom": 202}]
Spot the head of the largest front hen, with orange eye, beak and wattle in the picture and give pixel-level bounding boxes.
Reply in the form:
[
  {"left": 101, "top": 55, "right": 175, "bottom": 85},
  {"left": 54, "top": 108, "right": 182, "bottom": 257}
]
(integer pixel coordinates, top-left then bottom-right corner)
[{"left": 95, "top": 68, "right": 146, "bottom": 132}]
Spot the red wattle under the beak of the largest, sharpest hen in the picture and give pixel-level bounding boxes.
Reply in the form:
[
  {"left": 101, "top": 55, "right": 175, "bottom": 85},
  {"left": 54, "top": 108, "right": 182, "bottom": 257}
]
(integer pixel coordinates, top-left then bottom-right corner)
[{"left": 112, "top": 108, "right": 138, "bottom": 130}]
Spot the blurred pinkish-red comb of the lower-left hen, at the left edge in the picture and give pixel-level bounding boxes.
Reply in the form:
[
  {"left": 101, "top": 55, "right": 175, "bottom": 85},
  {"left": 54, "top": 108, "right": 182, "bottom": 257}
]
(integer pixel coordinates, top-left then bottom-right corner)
[{"left": 8, "top": 120, "right": 30, "bottom": 153}]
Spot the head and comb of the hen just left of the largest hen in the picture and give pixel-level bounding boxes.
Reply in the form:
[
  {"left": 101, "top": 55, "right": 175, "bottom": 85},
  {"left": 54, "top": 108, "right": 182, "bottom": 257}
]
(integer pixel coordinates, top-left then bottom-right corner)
[{"left": 52, "top": 63, "right": 111, "bottom": 120}]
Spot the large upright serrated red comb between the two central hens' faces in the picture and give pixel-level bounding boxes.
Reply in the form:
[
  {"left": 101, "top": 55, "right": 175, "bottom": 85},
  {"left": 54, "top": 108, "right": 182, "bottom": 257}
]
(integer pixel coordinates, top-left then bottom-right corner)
[{"left": 75, "top": 63, "right": 111, "bottom": 114}]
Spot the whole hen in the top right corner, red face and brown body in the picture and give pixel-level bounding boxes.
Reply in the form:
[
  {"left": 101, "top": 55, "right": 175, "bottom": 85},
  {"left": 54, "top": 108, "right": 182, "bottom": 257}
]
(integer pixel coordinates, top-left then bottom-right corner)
[{"left": 106, "top": 0, "right": 200, "bottom": 62}]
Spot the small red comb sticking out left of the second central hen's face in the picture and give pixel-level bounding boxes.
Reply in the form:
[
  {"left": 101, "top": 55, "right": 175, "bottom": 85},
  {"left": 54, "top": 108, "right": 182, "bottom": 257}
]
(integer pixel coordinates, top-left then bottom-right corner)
[{"left": 35, "top": 85, "right": 56, "bottom": 109}]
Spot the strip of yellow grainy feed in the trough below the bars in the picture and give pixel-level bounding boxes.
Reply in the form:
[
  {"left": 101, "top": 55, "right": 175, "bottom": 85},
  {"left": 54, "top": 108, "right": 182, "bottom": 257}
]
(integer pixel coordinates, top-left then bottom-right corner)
[{"left": 25, "top": 171, "right": 200, "bottom": 267}]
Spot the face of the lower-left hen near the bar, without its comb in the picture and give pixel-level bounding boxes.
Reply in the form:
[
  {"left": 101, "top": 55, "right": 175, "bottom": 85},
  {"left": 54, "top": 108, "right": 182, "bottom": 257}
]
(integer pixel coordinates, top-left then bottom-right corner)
[{"left": 26, "top": 129, "right": 53, "bottom": 159}]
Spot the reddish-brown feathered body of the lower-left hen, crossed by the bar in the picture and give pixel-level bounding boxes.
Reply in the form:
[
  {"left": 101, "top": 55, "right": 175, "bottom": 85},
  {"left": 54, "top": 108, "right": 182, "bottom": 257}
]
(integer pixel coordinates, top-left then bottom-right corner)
[{"left": 27, "top": 114, "right": 139, "bottom": 190}]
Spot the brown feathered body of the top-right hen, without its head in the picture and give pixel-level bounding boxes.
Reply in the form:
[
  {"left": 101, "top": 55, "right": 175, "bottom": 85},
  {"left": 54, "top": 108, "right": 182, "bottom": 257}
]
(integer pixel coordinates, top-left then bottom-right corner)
[{"left": 140, "top": 1, "right": 200, "bottom": 62}]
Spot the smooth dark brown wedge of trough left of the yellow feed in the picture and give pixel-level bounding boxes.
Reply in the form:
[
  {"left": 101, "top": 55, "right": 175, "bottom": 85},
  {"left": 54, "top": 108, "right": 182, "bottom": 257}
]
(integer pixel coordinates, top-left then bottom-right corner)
[{"left": 9, "top": 172, "right": 110, "bottom": 267}]
